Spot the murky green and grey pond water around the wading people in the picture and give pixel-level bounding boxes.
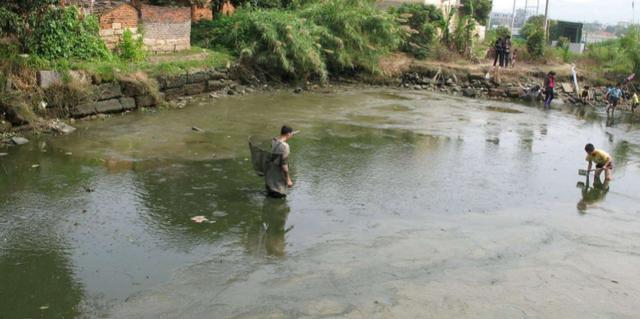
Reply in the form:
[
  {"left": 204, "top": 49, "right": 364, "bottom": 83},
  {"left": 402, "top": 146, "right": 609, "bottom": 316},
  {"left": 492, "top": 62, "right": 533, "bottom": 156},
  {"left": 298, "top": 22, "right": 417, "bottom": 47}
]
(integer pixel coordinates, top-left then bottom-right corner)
[{"left": 0, "top": 90, "right": 640, "bottom": 318}]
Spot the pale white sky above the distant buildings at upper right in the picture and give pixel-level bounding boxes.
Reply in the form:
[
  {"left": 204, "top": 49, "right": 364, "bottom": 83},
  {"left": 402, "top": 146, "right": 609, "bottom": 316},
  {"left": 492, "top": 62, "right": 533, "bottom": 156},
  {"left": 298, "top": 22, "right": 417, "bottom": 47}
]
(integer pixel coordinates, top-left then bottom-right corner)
[{"left": 493, "top": 0, "right": 640, "bottom": 24}]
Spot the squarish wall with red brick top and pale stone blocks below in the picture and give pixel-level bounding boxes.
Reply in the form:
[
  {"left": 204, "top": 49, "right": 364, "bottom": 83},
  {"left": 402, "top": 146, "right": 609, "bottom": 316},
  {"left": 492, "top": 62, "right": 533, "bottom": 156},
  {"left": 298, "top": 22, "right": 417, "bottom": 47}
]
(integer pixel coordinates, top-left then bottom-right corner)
[{"left": 141, "top": 5, "right": 191, "bottom": 52}]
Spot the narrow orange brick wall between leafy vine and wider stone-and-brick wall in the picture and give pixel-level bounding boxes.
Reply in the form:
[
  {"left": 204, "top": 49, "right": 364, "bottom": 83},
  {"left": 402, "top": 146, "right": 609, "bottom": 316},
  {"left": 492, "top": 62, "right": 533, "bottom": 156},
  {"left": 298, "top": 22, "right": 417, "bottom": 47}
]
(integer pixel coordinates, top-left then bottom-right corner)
[{"left": 100, "top": 4, "right": 139, "bottom": 49}]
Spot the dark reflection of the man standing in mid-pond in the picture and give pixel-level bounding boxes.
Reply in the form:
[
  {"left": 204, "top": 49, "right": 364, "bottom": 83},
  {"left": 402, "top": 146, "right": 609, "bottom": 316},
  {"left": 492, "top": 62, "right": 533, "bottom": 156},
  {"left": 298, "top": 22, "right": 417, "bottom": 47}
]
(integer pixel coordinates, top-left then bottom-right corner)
[{"left": 249, "top": 197, "right": 293, "bottom": 257}]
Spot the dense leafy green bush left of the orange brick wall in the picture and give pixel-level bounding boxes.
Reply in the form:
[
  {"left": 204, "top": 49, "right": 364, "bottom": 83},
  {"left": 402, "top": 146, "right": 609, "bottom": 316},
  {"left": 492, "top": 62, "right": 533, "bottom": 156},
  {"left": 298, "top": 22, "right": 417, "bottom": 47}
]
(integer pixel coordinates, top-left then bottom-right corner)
[{"left": 25, "top": 7, "right": 110, "bottom": 60}]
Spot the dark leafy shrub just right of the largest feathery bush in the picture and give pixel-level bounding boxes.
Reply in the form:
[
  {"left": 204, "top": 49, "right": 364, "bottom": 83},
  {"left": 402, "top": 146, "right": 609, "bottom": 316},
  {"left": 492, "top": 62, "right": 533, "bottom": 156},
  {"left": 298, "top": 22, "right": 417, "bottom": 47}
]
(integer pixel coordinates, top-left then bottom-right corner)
[{"left": 389, "top": 3, "right": 443, "bottom": 59}]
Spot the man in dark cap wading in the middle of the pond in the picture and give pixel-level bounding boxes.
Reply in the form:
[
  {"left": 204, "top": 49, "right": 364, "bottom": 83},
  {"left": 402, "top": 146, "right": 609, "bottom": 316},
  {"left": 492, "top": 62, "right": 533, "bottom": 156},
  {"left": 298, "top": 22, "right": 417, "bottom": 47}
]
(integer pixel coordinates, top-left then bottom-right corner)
[{"left": 265, "top": 125, "right": 293, "bottom": 197}]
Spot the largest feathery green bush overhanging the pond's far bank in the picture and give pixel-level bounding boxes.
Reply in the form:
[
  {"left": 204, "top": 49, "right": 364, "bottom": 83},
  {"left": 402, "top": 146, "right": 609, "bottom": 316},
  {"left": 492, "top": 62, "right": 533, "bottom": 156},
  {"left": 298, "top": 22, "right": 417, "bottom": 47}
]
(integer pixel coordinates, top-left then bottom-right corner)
[{"left": 192, "top": 0, "right": 404, "bottom": 80}]
